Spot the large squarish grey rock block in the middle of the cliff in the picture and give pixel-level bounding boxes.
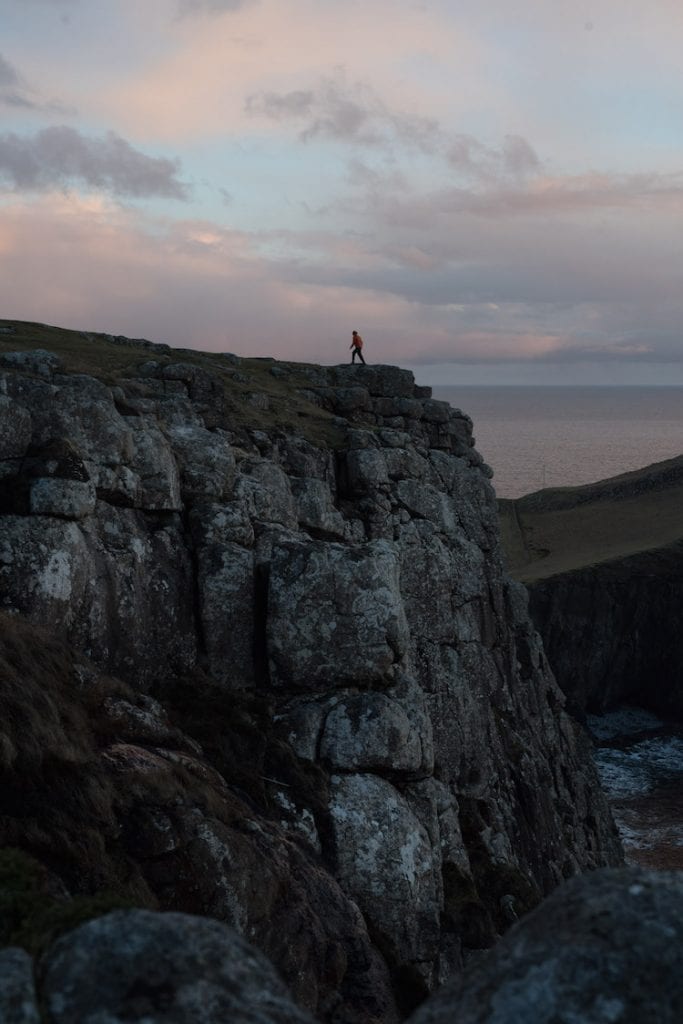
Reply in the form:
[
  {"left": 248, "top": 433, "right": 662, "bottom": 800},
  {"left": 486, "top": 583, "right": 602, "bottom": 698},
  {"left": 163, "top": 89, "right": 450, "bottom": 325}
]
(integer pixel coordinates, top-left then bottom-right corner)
[{"left": 267, "top": 541, "right": 409, "bottom": 690}]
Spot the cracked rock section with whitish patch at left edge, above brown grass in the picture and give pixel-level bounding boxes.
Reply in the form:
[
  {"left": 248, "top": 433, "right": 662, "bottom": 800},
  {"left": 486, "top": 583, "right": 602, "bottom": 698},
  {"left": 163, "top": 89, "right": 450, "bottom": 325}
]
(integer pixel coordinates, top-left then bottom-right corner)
[{"left": 0, "top": 503, "right": 197, "bottom": 687}]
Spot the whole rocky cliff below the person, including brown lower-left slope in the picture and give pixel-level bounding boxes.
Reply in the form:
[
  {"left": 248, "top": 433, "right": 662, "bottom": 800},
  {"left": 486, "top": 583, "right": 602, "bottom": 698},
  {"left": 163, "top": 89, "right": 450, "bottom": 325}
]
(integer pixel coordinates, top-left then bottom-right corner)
[{"left": 0, "top": 335, "right": 621, "bottom": 1021}]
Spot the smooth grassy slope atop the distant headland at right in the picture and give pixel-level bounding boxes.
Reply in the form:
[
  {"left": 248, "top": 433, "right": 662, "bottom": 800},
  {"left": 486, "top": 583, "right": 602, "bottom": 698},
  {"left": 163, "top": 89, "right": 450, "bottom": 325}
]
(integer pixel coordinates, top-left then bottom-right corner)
[{"left": 499, "top": 456, "right": 683, "bottom": 583}]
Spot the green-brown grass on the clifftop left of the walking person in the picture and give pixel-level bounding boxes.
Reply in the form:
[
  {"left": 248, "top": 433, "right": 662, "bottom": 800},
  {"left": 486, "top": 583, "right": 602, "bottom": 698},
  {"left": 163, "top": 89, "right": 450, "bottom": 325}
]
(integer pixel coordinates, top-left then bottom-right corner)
[{"left": 0, "top": 319, "right": 343, "bottom": 447}]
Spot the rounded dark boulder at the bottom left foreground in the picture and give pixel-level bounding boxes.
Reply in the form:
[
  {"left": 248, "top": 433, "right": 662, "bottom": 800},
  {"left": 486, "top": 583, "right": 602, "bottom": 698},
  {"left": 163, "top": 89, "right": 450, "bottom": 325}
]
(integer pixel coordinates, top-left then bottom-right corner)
[{"left": 28, "top": 910, "right": 311, "bottom": 1024}]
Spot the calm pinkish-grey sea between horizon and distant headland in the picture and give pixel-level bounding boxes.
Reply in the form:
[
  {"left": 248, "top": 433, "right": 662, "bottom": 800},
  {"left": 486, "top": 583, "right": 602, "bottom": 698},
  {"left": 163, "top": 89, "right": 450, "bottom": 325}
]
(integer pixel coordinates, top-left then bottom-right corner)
[{"left": 433, "top": 386, "right": 683, "bottom": 498}]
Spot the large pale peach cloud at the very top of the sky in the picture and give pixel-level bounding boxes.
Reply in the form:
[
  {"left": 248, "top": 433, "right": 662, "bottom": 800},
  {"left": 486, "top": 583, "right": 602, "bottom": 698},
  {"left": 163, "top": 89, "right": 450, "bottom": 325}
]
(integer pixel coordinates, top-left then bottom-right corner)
[{"left": 97, "top": 0, "right": 480, "bottom": 143}]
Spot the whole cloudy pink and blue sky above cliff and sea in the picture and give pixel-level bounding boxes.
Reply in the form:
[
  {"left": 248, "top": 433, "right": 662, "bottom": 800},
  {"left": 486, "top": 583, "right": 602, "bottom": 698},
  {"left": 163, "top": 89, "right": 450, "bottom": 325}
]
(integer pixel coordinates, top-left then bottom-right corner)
[{"left": 0, "top": 0, "right": 683, "bottom": 384}]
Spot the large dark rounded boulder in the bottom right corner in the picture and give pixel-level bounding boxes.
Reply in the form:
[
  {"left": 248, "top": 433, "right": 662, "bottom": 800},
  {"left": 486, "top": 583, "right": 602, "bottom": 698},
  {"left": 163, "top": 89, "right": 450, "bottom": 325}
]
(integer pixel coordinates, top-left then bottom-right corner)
[{"left": 410, "top": 868, "right": 683, "bottom": 1024}]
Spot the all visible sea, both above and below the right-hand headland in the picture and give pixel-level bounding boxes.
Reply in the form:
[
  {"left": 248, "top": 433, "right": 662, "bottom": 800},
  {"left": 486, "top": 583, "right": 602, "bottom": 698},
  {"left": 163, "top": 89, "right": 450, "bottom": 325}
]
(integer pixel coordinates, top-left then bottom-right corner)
[{"left": 434, "top": 386, "right": 683, "bottom": 869}]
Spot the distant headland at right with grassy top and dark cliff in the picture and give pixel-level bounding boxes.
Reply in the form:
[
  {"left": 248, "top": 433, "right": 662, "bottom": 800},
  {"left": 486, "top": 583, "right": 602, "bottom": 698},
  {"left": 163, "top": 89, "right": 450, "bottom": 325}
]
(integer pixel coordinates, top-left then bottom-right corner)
[{"left": 499, "top": 456, "right": 683, "bottom": 718}]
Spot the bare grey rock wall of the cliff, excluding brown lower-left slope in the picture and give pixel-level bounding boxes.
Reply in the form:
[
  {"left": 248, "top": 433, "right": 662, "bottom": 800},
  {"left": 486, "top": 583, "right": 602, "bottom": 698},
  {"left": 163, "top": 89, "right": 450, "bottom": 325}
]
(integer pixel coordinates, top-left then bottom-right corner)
[{"left": 0, "top": 350, "right": 621, "bottom": 1020}]
